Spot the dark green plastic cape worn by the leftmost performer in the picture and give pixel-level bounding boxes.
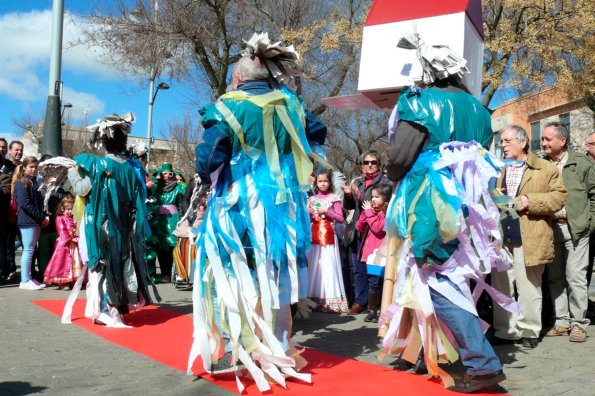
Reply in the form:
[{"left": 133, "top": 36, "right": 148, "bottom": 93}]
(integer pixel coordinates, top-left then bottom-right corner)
[{"left": 75, "top": 154, "right": 150, "bottom": 314}]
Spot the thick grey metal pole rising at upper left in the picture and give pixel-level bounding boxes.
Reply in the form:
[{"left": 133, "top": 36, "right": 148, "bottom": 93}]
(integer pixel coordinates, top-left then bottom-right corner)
[{"left": 41, "top": 0, "right": 64, "bottom": 156}]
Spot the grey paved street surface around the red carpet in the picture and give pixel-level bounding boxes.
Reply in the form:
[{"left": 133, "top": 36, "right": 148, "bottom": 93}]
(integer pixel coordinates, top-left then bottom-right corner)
[{"left": 0, "top": 255, "right": 595, "bottom": 396}]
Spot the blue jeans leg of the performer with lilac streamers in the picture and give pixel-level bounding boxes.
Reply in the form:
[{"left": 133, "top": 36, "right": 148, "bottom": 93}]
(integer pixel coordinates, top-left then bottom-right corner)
[{"left": 430, "top": 275, "right": 502, "bottom": 375}]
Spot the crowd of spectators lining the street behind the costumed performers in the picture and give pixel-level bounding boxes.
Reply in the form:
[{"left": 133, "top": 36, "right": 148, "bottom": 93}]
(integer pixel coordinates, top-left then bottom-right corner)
[{"left": 0, "top": 127, "right": 595, "bottom": 349}]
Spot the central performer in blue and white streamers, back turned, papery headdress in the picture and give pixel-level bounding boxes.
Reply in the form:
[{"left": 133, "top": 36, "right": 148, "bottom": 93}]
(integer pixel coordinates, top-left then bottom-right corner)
[{"left": 189, "top": 33, "right": 326, "bottom": 392}]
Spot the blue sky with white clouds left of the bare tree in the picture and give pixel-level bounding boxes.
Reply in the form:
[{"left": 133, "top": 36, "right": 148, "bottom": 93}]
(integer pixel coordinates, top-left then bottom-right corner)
[{"left": 0, "top": 0, "right": 198, "bottom": 153}]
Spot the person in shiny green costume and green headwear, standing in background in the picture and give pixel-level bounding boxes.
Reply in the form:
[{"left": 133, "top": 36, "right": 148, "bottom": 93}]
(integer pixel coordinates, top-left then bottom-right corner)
[{"left": 153, "top": 162, "right": 186, "bottom": 283}]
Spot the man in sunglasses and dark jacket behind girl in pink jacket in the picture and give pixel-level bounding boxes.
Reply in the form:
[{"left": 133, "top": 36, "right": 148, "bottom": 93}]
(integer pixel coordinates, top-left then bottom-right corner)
[{"left": 343, "top": 150, "right": 390, "bottom": 315}]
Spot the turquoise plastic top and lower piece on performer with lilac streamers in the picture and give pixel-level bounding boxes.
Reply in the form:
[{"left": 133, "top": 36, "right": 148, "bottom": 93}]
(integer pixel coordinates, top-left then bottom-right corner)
[{"left": 397, "top": 88, "right": 492, "bottom": 266}]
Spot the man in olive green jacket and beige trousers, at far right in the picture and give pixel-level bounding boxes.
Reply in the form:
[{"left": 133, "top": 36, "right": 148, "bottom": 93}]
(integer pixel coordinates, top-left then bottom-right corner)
[{"left": 541, "top": 122, "right": 595, "bottom": 342}]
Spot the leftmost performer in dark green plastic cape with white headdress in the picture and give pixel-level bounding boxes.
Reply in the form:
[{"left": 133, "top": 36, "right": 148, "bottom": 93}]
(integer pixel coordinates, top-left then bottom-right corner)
[{"left": 62, "top": 113, "right": 151, "bottom": 327}]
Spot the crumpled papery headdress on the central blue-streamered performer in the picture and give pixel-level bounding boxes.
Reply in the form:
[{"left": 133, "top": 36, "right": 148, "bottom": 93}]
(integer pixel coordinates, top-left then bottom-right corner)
[{"left": 242, "top": 32, "right": 301, "bottom": 84}]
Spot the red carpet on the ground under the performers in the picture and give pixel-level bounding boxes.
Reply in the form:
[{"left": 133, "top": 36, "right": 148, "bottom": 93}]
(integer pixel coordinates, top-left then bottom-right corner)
[{"left": 33, "top": 300, "right": 506, "bottom": 395}]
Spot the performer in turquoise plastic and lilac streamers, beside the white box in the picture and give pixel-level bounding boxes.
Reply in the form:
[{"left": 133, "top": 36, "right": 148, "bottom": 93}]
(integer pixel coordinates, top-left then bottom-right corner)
[{"left": 379, "top": 35, "right": 518, "bottom": 392}]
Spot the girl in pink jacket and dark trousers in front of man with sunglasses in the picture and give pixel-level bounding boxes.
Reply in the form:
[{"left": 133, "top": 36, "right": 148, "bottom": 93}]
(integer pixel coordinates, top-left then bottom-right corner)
[{"left": 355, "top": 184, "right": 393, "bottom": 322}]
